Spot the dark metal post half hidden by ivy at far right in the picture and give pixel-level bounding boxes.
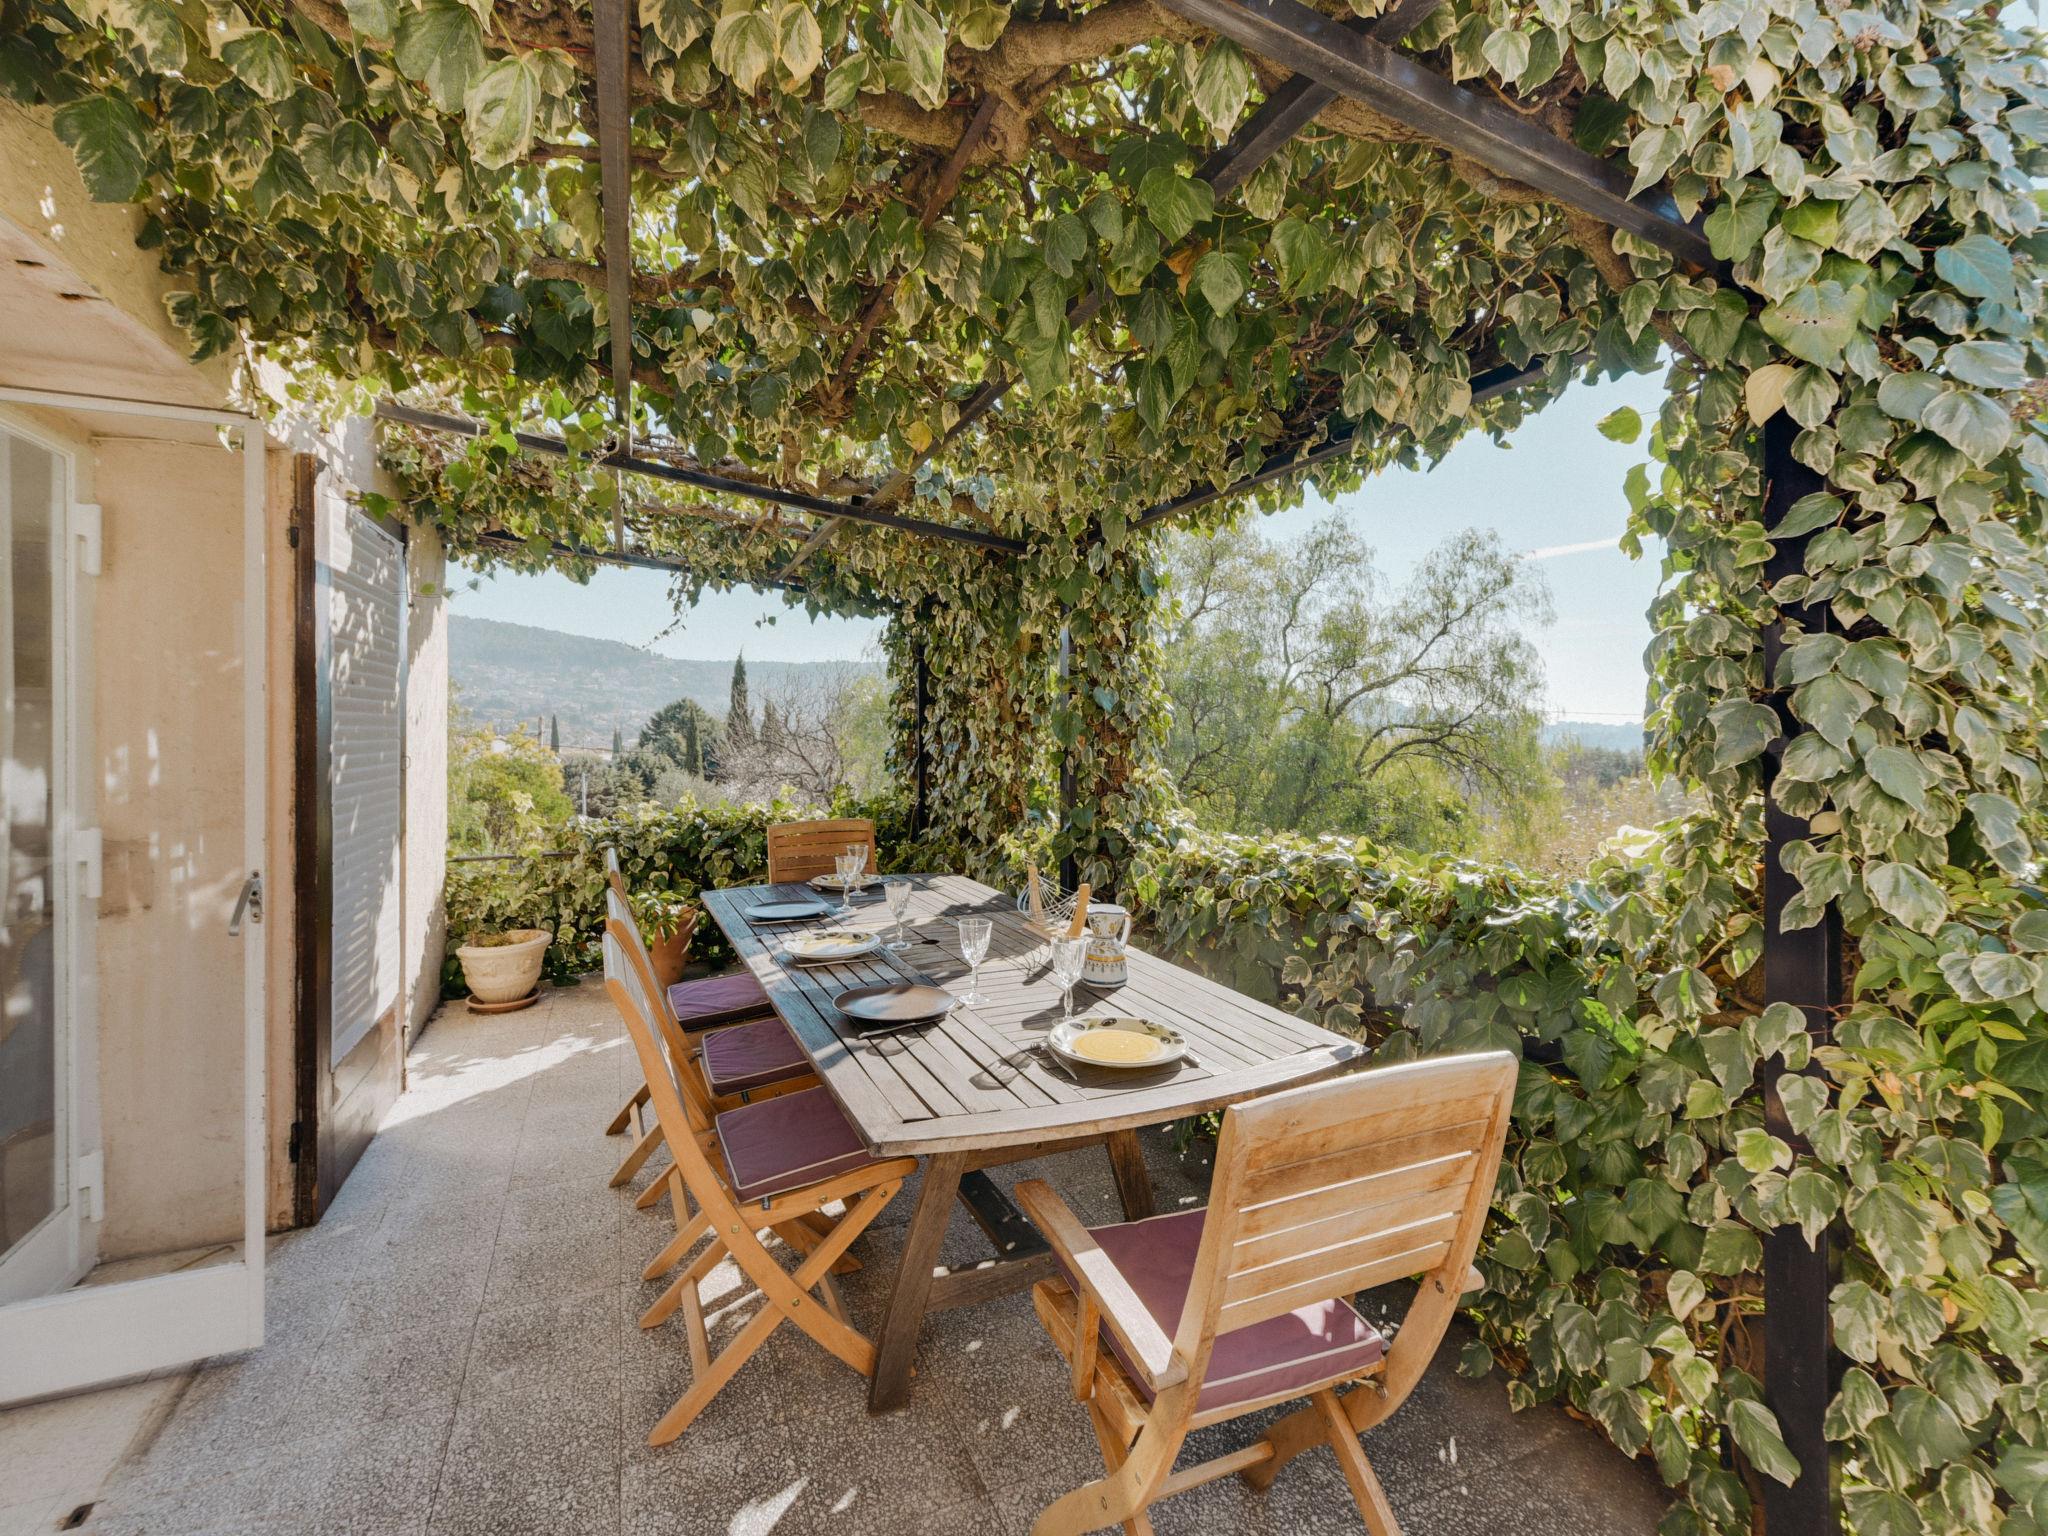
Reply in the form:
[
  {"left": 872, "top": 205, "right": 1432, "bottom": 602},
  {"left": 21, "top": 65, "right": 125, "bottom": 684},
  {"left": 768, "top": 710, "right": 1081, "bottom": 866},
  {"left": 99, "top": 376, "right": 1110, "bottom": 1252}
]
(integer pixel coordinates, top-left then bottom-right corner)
[{"left": 1761, "top": 412, "right": 1841, "bottom": 1536}]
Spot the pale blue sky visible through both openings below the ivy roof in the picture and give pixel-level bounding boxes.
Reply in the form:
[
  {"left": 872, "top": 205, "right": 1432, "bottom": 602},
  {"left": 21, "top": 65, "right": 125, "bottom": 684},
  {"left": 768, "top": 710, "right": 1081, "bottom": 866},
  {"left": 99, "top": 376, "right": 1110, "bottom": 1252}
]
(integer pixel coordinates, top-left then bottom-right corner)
[{"left": 451, "top": 375, "right": 1661, "bottom": 721}]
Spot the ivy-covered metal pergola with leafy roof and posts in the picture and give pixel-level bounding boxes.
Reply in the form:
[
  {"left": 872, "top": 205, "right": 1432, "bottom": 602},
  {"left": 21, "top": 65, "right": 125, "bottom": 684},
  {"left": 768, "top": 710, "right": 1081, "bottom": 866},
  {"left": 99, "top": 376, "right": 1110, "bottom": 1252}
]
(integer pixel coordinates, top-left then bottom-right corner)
[{"left": 24, "top": 0, "right": 2048, "bottom": 1532}]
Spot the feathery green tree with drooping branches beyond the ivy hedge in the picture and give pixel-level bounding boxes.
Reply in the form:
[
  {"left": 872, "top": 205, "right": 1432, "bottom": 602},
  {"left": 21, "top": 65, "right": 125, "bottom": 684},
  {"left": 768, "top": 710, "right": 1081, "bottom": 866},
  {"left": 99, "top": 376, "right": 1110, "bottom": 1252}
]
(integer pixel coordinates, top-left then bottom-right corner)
[{"left": 1165, "top": 518, "right": 1548, "bottom": 848}]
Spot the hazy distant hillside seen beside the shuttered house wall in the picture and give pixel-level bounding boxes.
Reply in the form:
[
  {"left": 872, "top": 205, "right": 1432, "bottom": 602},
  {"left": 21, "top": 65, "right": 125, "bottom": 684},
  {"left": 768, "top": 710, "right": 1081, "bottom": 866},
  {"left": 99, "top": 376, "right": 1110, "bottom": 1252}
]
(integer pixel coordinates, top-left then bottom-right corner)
[{"left": 449, "top": 614, "right": 883, "bottom": 748}]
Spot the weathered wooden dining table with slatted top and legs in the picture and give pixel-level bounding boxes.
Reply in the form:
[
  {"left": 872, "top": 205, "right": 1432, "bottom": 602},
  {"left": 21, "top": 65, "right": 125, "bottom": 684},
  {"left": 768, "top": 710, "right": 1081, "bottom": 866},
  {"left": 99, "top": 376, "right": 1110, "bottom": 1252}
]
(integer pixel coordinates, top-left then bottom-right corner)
[{"left": 702, "top": 874, "right": 1362, "bottom": 1413}]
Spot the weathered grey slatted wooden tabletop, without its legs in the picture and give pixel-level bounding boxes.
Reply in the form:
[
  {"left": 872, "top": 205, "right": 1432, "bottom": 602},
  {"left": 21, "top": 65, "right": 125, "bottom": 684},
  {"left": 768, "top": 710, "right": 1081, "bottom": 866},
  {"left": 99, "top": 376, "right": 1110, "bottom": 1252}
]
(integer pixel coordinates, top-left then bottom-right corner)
[{"left": 705, "top": 874, "right": 1360, "bottom": 1155}]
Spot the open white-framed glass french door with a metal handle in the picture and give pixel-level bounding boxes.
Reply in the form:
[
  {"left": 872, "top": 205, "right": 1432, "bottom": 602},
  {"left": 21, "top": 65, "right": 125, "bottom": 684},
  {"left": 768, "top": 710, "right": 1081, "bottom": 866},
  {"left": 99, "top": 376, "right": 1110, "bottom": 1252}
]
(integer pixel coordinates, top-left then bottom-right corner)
[{"left": 0, "top": 385, "right": 268, "bottom": 1405}]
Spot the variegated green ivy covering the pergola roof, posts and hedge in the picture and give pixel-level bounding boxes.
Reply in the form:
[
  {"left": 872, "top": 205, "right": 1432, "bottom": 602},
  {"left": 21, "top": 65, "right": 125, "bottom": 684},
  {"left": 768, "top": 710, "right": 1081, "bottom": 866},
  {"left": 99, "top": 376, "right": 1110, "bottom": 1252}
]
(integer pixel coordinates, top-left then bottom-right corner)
[{"left": 0, "top": 0, "right": 2048, "bottom": 1536}]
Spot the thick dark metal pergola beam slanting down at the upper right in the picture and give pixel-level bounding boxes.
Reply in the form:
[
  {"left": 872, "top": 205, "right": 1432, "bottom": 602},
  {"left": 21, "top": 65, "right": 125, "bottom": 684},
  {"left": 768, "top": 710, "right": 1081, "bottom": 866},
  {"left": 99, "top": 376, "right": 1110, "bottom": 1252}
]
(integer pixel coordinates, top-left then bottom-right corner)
[{"left": 1159, "top": 0, "right": 1718, "bottom": 270}]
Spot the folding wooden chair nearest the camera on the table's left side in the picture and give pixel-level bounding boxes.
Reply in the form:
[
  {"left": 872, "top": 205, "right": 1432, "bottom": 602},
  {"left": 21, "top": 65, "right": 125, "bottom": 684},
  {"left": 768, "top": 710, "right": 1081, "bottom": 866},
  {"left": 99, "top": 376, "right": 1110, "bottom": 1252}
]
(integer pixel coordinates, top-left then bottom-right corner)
[{"left": 604, "top": 922, "right": 918, "bottom": 1446}]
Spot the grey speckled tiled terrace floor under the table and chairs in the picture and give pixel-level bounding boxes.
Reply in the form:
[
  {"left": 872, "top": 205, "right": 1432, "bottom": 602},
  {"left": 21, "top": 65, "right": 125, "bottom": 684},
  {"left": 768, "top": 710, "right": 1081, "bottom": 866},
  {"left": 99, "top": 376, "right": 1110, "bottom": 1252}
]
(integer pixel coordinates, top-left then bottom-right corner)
[{"left": 24, "top": 985, "right": 1663, "bottom": 1536}]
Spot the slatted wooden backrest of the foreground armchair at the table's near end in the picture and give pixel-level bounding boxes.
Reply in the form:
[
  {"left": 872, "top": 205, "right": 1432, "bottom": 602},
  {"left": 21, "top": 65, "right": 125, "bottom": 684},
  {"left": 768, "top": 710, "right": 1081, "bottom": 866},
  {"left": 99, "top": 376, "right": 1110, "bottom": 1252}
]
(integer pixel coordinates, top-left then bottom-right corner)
[{"left": 1174, "top": 1051, "right": 1516, "bottom": 1380}]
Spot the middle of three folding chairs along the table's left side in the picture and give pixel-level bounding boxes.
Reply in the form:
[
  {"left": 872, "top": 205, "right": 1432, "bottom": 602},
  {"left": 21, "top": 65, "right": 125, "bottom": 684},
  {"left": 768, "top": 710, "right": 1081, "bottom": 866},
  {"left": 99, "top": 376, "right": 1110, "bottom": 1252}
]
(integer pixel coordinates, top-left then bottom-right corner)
[{"left": 604, "top": 870, "right": 817, "bottom": 1208}]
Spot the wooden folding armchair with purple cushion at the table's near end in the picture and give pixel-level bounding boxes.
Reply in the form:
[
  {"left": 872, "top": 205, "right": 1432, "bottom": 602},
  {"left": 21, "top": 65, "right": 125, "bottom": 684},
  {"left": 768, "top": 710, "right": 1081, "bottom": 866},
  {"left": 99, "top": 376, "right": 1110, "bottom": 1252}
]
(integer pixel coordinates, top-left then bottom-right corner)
[{"left": 1016, "top": 1051, "right": 1516, "bottom": 1536}]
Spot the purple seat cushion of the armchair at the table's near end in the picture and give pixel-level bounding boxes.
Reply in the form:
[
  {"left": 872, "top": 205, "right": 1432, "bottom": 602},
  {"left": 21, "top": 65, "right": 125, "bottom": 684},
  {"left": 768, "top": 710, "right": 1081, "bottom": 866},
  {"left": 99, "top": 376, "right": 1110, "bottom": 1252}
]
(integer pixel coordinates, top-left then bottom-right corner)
[{"left": 1090, "top": 1210, "right": 1386, "bottom": 1413}]
